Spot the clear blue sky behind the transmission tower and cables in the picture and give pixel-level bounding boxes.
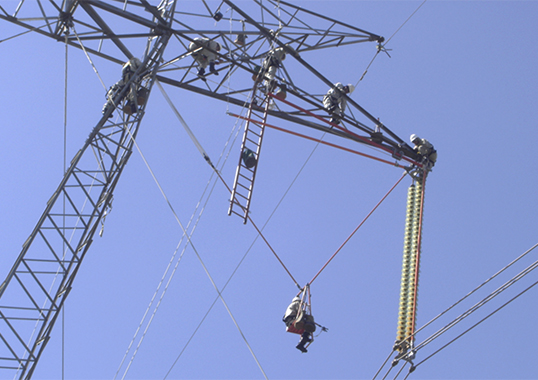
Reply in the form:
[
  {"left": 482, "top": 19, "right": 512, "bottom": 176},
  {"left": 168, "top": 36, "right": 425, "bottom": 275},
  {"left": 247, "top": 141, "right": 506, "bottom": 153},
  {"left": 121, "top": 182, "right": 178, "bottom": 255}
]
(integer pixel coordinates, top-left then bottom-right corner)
[{"left": 0, "top": 0, "right": 538, "bottom": 379}]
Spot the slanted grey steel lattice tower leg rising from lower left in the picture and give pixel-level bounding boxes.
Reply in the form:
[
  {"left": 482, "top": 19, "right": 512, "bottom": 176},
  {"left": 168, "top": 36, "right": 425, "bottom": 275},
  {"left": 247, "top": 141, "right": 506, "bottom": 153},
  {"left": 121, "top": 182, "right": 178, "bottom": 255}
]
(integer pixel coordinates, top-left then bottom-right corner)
[{"left": 0, "top": 0, "right": 174, "bottom": 379}]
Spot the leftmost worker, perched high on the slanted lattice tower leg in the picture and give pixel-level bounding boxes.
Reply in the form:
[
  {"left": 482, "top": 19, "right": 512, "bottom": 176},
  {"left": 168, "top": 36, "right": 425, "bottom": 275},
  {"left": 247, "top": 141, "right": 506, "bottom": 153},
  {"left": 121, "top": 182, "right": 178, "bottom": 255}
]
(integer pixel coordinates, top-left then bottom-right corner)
[{"left": 102, "top": 58, "right": 143, "bottom": 117}]
